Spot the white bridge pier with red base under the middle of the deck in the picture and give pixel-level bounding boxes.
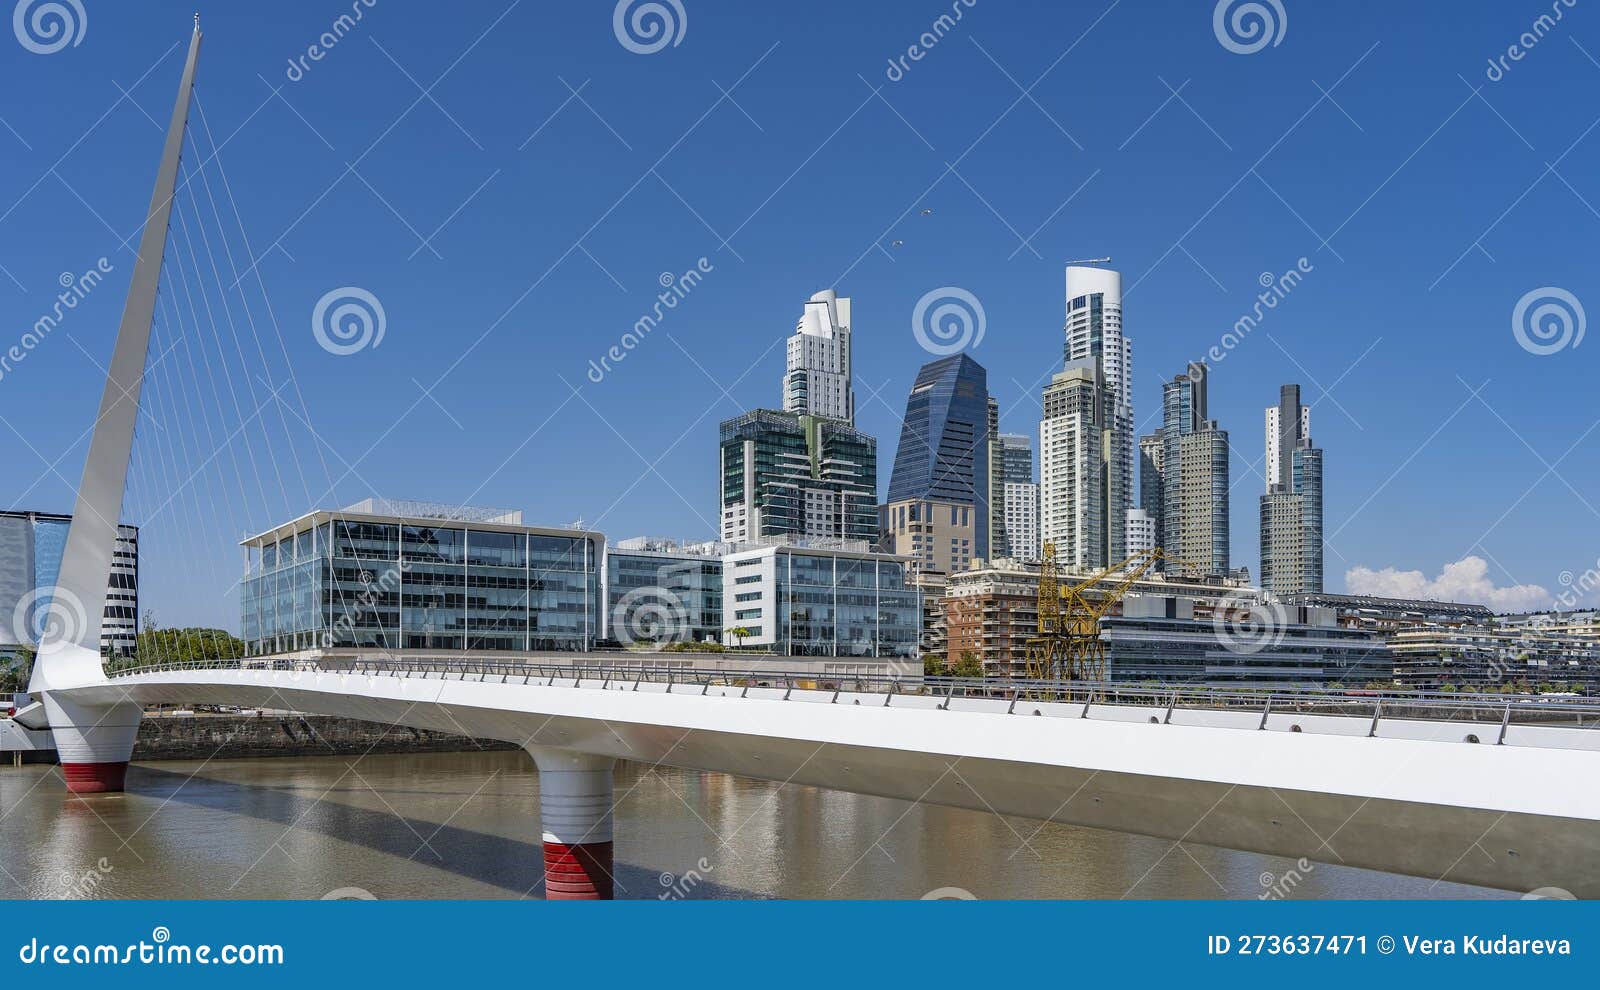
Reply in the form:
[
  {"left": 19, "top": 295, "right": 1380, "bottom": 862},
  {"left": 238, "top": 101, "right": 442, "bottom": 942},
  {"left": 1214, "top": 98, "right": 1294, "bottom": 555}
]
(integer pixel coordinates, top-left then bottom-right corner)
[{"left": 528, "top": 745, "right": 616, "bottom": 900}]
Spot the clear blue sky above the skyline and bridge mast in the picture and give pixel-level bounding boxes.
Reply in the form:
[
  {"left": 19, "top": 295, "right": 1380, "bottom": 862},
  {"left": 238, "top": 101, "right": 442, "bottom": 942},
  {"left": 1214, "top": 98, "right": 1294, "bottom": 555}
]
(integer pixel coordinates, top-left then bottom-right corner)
[{"left": 0, "top": 0, "right": 1600, "bottom": 625}]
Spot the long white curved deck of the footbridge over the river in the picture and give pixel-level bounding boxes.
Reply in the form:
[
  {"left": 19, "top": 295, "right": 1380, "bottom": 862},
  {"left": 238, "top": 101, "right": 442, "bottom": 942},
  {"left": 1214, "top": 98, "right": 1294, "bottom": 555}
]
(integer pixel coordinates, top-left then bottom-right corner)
[{"left": 40, "top": 654, "right": 1600, "bottom": 897}]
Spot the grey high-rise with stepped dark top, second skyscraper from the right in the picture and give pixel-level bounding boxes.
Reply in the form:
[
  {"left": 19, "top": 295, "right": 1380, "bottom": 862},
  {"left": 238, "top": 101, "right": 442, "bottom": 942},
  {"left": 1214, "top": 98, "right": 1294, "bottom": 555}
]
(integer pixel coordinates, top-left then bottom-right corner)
[{"left": 1162, "top": 363, "right": 1229, "bottom": 577}]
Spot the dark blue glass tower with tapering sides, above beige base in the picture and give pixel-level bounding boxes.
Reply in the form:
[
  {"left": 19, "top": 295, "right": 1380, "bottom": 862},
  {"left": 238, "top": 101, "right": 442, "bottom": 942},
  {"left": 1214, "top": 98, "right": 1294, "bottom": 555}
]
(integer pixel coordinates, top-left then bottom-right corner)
[{"left": 888, "top": 353, "right": 989, "bottom": 557}]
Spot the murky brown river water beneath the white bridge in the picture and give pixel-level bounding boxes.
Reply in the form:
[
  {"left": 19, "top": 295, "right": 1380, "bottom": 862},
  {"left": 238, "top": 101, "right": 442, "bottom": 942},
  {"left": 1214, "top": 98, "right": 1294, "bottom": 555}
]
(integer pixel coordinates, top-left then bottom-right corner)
[{"left": 0, "top": 752, "right": 1517, "bottom": 899}]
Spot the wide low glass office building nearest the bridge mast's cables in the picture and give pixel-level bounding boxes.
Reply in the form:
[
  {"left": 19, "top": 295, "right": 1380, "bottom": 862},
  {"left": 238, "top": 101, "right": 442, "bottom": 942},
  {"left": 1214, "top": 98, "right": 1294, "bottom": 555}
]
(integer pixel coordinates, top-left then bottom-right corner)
[{"left": 242, "top": 501, "right": 605, "bottom": 656}]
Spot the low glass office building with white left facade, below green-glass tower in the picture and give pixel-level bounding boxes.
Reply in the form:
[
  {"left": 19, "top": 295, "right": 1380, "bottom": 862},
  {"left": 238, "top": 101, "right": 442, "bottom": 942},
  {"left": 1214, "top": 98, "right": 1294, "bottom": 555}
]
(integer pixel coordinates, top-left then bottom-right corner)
[{"left": 722, "top": 545, "right": 922, "bottom": 659}]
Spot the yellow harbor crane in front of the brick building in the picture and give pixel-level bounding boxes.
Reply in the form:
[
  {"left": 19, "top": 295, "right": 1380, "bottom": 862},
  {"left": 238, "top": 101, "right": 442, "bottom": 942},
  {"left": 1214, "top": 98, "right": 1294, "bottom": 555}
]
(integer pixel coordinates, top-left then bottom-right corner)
[{"left": 1027, "top": 542, "right": 1168, "bottom": 681}]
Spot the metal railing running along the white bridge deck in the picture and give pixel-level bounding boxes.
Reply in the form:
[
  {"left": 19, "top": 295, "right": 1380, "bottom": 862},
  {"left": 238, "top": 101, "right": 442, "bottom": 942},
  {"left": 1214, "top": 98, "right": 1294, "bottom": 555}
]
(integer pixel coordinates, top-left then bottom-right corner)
[{"left": 110, "top": 657, "right": 1600, "bottom": 733}]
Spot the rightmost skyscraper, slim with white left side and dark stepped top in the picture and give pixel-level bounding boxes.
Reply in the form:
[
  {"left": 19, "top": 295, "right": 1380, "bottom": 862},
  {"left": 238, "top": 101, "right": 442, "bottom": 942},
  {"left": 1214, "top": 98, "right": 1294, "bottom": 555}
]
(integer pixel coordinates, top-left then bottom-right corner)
[{"left": 1261, "top": 385, "right": 1322, "bottom": 597}]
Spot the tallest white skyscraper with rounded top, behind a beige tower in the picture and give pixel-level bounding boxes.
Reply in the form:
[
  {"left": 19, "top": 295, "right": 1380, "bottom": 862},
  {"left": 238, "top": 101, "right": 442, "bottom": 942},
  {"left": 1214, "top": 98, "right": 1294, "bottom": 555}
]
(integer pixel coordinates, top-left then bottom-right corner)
[{"left": 1062, "top": 265, "right": 1133, "bottom": 563}]
